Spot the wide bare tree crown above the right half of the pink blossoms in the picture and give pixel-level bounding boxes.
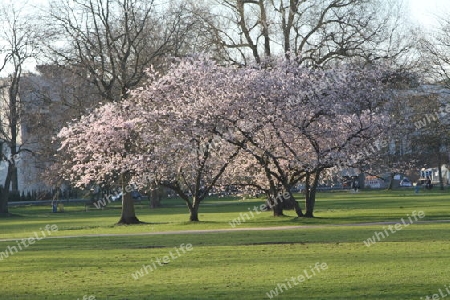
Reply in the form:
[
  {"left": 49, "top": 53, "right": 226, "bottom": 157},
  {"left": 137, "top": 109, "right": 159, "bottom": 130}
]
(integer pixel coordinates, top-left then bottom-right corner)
[{"left": 200, "top": 0, "right": 409, "bottom": 66}]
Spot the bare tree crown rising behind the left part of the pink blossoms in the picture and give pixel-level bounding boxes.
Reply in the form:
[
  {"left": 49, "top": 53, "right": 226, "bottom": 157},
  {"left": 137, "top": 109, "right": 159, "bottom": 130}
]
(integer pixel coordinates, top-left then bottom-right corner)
[{"left": 47, "top": 0, "right": 198, "bottom": 101}]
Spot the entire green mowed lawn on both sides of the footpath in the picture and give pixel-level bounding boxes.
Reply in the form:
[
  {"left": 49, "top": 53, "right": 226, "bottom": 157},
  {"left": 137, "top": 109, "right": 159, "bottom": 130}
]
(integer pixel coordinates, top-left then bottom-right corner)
[{"left": 0, "top": 189, "right": 450, "bottom": 300}]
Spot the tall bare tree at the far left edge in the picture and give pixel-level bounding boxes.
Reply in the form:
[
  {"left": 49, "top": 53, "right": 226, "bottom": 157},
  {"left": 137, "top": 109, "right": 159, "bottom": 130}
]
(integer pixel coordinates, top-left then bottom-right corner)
[{"left": 0, "top": 3, "right": 39, "bottom": 214}]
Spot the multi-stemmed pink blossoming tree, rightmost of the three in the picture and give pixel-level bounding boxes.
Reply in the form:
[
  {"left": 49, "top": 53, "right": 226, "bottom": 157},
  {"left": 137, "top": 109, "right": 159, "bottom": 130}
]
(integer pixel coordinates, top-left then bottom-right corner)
[{"left": 217, "top": 62, "right": 385, "bottom": 217}]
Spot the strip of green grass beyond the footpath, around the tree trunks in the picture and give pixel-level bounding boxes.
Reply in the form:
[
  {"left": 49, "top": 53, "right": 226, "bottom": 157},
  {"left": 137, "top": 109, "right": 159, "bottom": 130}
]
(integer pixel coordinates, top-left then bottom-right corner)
[{"left": 0, "top": 189, "right": 450, "bottom": 239}]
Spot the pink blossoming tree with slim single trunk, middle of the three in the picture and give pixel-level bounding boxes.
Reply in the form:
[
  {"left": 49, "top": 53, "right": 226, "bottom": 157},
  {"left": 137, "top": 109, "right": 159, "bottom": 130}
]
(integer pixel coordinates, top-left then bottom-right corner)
[{"left": 127, "top": 58, "right": 250, "bottom": 221}]
